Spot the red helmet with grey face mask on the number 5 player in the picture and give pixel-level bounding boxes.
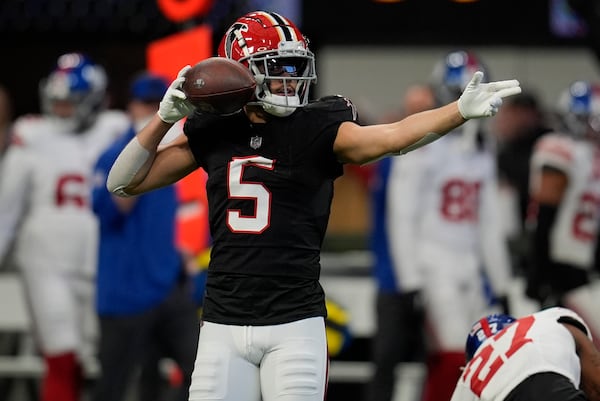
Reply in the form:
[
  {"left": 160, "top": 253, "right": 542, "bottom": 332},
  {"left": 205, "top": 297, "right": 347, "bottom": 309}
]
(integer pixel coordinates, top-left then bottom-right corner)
[{"left": 218, "top": 11, "right": 317, "bottom": 117}]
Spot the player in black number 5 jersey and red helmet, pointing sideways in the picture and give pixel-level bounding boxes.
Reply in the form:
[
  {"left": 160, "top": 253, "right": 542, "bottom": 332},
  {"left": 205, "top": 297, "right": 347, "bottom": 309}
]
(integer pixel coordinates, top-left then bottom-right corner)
[{"left": 107, "top": 11, "right": 520, "bottom": 401}]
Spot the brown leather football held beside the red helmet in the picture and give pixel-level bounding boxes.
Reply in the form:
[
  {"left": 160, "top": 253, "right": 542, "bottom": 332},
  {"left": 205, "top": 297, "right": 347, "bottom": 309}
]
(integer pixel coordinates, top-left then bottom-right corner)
[{"left": 182, "top": 57, "right": 256, "bottom": 114}]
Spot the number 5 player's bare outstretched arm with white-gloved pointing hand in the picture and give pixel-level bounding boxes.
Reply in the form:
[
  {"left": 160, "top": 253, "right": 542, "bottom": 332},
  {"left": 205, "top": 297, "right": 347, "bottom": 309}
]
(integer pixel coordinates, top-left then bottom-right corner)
[{"left": 334, "top": 71, "right": 521, "bottom": 164}]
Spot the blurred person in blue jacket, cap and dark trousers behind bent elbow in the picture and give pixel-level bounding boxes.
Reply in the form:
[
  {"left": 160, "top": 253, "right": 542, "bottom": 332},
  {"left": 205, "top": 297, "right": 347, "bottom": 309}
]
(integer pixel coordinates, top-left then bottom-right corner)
[{"left": 92, "top": 73, "right": 199, "bottom": 401}]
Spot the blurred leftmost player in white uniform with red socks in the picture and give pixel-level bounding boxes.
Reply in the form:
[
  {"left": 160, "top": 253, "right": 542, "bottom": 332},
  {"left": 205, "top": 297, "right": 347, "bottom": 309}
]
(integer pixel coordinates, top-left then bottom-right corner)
[{"left": 0, "top": 53, "right": 128, "bottom": 401}]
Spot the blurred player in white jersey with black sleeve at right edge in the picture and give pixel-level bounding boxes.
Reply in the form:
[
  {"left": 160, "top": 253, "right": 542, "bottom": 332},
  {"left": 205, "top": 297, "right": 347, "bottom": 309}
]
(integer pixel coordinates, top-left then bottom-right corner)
[{"left": 527, "top": 81, "right": 600, "bottom": 344}]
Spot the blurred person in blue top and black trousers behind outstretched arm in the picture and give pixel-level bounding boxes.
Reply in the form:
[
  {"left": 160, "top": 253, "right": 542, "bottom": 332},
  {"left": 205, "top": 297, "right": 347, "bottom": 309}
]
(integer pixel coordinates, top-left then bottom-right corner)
[{"left": 366, "top": 85, "right": 436, "bottom": 401}]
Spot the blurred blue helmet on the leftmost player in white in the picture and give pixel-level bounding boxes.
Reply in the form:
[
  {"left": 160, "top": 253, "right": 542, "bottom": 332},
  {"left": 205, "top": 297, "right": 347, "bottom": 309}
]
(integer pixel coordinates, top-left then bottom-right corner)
[{"left": 40, "top": 53, "right": 108, "bottom": 132}]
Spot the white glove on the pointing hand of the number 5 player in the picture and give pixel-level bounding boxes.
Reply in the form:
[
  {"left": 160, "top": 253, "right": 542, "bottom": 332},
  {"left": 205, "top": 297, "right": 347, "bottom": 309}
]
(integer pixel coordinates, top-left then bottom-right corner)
[{"left": 458, "top": 71, "right": 521, "bottom": 120}]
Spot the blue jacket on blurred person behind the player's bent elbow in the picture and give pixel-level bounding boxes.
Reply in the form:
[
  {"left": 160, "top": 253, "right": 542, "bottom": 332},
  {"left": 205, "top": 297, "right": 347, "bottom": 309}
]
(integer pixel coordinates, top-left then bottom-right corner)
[{"left": 92, "top": 128, "right": 183, "bottom": 316}]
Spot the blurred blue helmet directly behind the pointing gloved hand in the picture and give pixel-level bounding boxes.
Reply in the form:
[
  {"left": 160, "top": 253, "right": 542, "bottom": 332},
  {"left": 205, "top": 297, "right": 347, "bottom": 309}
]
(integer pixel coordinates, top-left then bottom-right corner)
[{"left": 431, "top": 50, "right": 489, "bottom": 104}]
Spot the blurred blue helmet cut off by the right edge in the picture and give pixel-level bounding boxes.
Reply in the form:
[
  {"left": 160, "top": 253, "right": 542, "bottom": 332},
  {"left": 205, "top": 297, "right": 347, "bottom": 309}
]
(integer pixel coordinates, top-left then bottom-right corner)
[{"left": 558, "top": 80, "right": 600, "bottom": 137}]
